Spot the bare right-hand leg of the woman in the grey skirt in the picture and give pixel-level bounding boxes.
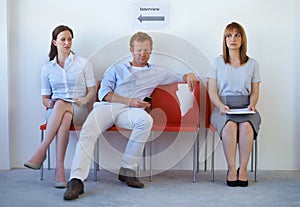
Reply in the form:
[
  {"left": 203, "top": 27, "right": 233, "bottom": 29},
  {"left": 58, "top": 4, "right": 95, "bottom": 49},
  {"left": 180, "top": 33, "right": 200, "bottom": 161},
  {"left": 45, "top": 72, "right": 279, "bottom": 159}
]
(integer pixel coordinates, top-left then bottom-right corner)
[{"left": 238, "top": 122, "right": 253, "bottom": 181}]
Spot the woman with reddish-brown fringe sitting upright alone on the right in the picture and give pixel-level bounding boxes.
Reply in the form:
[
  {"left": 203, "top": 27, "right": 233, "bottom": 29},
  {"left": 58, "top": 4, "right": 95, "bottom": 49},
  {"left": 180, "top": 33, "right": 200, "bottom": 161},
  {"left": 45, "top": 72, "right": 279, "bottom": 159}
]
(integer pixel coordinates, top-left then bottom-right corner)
[{"left": 207, "top": 22, "right": 261, "bottom": 187}]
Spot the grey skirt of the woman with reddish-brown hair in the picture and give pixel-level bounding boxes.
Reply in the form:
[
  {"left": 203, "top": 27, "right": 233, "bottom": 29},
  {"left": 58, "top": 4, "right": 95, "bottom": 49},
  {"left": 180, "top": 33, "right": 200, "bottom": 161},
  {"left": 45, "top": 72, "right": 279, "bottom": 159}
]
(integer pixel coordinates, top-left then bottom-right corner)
[{"left": 211, "top": 96, "right": 261, "bottom": 139}]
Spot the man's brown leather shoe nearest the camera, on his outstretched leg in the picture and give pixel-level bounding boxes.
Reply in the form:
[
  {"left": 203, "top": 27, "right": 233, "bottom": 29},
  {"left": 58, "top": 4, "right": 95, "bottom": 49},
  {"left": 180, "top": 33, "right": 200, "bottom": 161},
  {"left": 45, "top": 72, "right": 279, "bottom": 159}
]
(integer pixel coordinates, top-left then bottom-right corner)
[{"left": 64, "top": 178, "right": 84, "bottom": 200}]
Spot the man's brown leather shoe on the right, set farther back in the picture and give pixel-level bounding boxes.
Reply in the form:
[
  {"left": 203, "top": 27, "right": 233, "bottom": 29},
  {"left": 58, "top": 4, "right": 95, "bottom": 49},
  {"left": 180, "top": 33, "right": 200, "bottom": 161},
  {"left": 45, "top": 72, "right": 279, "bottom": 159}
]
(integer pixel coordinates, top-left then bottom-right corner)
[{"left": 119, "top": 167, "right": 144, "bottom": 188}]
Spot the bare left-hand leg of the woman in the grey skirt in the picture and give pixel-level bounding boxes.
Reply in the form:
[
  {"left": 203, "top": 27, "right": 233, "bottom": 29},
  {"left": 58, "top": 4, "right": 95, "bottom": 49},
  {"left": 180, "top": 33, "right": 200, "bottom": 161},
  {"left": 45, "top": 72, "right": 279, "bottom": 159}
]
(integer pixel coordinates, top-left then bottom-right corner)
[{"left": 222, "top": 121, "right": 238, "bottom": 181}]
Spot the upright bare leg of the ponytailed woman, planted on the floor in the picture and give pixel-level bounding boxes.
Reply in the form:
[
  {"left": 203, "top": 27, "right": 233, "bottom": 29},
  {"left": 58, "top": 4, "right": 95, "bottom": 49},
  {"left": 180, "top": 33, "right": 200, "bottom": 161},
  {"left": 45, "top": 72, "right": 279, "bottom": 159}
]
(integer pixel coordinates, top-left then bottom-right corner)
[{"left": 55, "top": 112, "right": 72, "bottom": 182}]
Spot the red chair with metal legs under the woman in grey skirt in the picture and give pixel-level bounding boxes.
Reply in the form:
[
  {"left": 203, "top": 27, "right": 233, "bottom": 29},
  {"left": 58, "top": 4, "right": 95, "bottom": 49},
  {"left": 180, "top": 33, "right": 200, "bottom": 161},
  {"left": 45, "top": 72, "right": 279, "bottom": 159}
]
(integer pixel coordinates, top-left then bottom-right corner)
[{"left": 204, "top": 90, "right": 257, "bottom": 182}]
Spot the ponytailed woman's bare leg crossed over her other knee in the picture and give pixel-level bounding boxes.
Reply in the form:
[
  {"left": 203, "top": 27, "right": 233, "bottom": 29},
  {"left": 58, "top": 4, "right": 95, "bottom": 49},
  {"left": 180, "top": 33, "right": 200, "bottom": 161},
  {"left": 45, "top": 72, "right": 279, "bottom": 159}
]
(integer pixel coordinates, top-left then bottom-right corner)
[{"left": 29, "top": 100, "right": 73, "bottom": 164}]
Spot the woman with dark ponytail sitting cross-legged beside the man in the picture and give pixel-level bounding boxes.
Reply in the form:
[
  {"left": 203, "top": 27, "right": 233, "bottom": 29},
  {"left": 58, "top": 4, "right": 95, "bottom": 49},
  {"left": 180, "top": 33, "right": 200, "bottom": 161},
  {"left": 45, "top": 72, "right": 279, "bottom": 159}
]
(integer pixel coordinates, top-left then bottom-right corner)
[{"left": 24, "top": 25, "right": 96, "bottom": 188}]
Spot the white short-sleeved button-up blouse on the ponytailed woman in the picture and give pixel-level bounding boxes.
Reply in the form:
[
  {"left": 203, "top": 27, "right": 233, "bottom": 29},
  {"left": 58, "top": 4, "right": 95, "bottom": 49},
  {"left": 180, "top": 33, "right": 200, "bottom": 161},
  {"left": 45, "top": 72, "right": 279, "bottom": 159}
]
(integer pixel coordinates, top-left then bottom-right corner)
[{"left": 41, "top": 53, "right": 96, "bottom": 99}]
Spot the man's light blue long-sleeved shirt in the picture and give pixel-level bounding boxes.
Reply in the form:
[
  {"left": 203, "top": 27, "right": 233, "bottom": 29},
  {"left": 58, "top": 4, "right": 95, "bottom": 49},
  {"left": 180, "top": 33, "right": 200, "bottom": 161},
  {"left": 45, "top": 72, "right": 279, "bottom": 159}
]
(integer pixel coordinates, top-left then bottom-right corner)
[{"left": 98, "top": 62, "right": 182, "bottom": 101}]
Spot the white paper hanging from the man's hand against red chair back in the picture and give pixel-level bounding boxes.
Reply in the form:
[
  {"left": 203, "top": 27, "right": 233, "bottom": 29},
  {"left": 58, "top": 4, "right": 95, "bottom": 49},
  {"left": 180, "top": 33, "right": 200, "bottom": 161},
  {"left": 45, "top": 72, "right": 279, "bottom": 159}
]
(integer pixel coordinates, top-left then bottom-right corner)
[{"left": 176, "top": 84, "right": 194, "bottom": 116}]
